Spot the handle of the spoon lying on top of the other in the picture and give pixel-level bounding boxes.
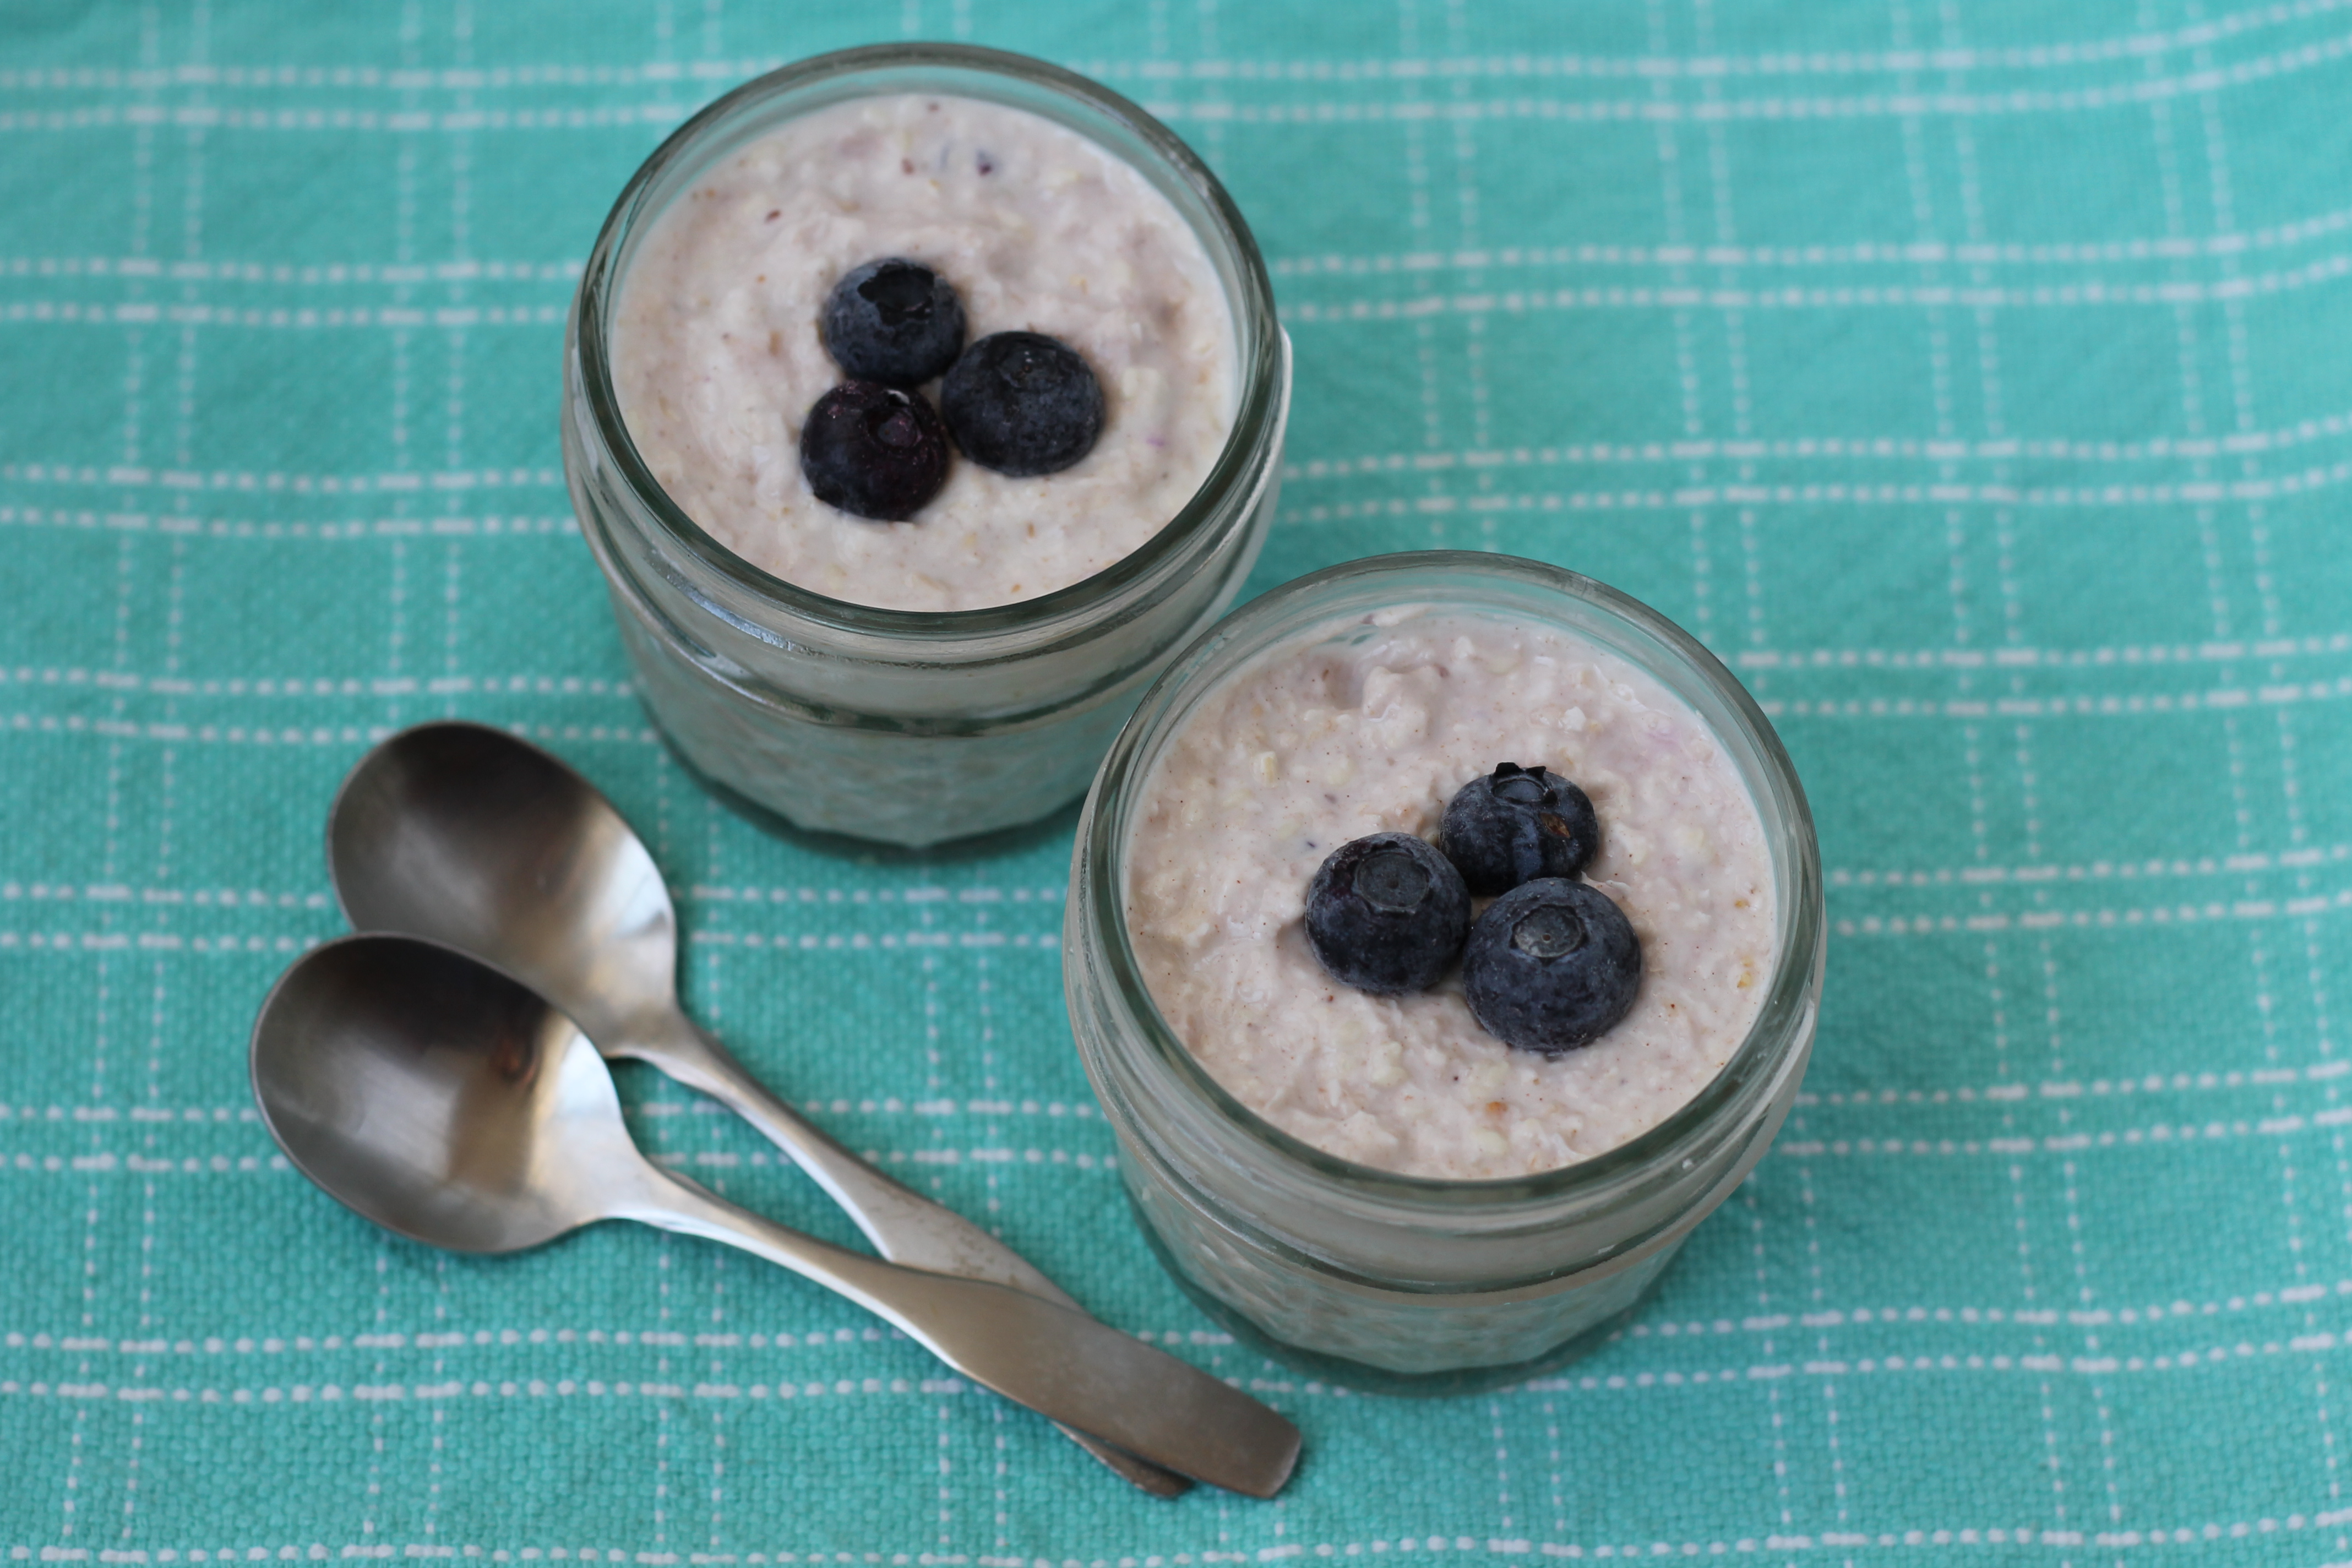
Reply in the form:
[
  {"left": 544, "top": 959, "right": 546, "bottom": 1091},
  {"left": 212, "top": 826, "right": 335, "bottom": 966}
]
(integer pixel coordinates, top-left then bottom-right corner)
[{"left": 607, "top": 1166, "right": 1298, "bottom": 1498}]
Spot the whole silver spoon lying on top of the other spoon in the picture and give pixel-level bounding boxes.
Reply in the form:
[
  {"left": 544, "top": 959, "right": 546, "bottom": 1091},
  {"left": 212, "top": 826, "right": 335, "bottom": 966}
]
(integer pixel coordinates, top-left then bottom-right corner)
[{"left": 252, "top": 935, "right": 1298, "bottom": 1498}]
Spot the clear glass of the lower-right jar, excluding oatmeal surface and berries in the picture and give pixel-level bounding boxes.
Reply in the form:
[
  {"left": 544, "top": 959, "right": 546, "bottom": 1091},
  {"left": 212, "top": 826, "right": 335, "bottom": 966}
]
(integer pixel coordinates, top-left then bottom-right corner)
[{"left": 1063, "top": 552, "right": 1825, "bottom": 1392}]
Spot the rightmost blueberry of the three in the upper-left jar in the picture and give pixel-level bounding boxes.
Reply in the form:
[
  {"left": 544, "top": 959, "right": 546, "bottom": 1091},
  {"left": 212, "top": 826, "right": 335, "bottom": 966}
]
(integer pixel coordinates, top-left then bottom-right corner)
[{"left": 939, "top": 331, "right": 1103, "bottom": 480}]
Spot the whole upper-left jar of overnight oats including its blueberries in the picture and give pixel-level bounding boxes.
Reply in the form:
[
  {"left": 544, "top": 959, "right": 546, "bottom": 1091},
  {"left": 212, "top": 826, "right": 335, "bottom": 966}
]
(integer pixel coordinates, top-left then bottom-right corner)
[{"left": 564, "top": 45, "right": 1289, "bottom": 844}]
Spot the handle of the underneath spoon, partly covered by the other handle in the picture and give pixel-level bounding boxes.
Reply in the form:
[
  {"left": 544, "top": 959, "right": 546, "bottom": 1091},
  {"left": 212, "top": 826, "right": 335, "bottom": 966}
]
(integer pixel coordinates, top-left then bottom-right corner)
[{"left": 616, "top": 1013, "right": 1190, "bottom": 1498}]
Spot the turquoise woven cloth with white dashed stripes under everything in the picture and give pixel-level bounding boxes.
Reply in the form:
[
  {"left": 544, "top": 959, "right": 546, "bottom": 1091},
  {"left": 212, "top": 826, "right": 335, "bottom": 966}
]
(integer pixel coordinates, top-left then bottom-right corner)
[{"left": 0, "top": 0, "right": 2352, "bottom": 1568}]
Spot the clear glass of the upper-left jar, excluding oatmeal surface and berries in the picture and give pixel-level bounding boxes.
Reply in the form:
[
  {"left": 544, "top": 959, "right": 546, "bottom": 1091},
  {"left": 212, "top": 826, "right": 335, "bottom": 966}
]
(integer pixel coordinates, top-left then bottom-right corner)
[{"left": 562, "top": 45, "right": 1291, "bottom": 844}]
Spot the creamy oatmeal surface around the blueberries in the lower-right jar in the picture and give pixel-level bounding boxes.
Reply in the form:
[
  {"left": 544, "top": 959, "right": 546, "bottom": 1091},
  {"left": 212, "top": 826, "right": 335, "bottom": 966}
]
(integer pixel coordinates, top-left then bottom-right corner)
[{"left": 1126, "top": 609, "right": 1773, "bottom": 1180}]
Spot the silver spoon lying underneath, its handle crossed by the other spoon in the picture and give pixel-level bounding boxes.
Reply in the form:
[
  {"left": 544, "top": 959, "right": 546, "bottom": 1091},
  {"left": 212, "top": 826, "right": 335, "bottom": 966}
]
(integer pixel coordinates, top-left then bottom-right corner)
[{"left": 327, "top": 722, "right": 1185, "bottom": 1498}]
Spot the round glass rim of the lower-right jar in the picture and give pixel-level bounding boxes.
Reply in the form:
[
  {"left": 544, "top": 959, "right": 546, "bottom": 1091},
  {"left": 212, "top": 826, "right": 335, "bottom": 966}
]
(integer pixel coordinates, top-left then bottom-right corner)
[{"left": 1072, "top": 550, "right": 1827, "bottom": 1216}]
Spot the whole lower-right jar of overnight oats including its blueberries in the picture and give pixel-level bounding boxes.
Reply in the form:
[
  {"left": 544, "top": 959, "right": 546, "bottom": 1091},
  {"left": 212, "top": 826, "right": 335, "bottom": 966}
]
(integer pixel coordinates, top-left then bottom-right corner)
[{"left": 1063, "top": 555, "right": 1823, "bottom": 1389}]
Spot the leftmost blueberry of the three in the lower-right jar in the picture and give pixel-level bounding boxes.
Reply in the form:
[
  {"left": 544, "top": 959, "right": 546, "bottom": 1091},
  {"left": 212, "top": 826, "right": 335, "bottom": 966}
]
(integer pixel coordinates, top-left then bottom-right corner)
[{"left": 1308, "top": 832, "right": 1470, "bottom": 997}]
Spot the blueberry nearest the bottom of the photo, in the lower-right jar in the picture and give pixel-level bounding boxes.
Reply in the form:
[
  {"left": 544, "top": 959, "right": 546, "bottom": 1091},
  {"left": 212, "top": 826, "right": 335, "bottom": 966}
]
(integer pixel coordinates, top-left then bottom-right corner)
[{"left": 1463, "top": 877, "right": 1642, "bottom": 1055}]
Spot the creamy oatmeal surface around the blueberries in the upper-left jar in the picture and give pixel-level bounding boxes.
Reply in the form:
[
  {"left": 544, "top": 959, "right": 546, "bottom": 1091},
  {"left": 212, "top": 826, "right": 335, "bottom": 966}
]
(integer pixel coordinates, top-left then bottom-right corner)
[{"left": 612, "top": 94, "right": 1235, "bottom": 611}]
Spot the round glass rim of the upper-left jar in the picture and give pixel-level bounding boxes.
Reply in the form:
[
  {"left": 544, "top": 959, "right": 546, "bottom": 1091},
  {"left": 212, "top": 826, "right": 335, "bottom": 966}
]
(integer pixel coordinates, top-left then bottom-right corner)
[{"left": 574, "top": 42, "right": 1287, "bottom": 644}]
